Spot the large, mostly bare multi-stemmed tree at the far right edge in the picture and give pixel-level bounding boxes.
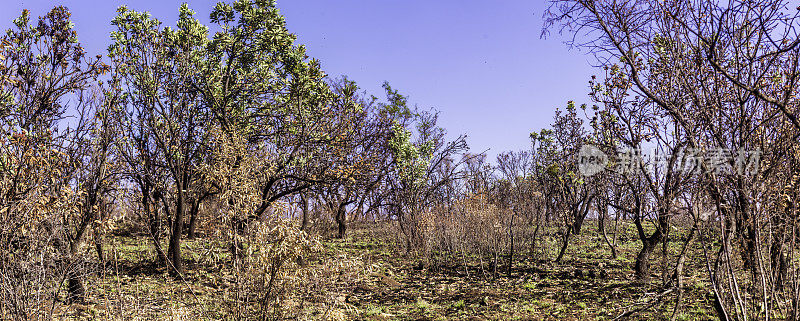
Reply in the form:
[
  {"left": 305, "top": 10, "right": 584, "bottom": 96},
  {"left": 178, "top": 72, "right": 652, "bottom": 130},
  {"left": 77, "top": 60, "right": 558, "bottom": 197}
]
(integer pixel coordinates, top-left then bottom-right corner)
[{"left": 546, "top": 0, "right": 800, "bottom": 319}]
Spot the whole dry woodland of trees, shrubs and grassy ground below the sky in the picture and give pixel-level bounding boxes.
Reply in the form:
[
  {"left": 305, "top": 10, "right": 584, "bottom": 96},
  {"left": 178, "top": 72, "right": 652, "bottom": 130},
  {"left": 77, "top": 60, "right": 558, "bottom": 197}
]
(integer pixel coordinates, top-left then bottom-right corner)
[{"left": 0, "top": 0, "right": 800, "bottom": 320}]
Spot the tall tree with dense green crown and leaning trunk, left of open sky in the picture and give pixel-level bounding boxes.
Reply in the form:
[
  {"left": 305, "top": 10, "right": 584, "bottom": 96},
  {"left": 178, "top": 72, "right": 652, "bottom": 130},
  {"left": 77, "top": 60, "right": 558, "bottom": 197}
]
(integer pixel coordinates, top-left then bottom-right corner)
[{"left": 200, "top": 0, "right": 334, "bottom": 238}]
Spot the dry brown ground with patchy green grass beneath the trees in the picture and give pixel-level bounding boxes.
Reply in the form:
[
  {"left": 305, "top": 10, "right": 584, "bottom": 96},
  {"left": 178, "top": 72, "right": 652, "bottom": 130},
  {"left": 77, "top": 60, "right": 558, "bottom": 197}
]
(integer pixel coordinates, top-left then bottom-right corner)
[{"left": 57, "top": 222, "right": 714, "bottom": 320}]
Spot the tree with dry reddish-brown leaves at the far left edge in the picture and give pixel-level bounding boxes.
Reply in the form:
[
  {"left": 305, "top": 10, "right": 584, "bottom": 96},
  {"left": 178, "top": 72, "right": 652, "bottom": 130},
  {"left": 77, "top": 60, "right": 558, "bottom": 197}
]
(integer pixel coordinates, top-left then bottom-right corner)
[{"left": 0, "top": 7, "right": 107, "bottom": 312}]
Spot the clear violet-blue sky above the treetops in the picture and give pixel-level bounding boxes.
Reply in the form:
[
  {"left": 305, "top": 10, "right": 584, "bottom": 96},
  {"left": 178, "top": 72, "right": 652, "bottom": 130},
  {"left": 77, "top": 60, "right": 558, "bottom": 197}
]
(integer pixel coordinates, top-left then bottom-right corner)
[{"left": 0, "top": 0, "right": 597, "bottom": 159}]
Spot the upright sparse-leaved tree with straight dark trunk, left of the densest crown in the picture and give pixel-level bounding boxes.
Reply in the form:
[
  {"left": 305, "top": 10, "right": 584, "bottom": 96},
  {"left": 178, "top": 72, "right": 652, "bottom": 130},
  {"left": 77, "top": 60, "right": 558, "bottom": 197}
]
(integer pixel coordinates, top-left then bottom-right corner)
[{"left": 109, "top": 4, "right": 211, "bottom": 274}]
